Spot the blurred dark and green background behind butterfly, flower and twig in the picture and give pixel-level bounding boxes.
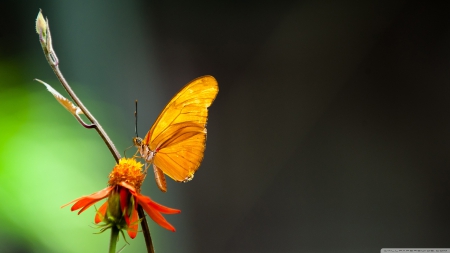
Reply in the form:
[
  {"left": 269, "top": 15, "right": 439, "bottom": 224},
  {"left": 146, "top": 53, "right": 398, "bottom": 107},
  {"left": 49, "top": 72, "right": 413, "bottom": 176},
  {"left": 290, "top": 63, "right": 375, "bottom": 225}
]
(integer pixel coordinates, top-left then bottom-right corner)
[{"left": 0, "top": 0, "right": 450, "bottom": 253}]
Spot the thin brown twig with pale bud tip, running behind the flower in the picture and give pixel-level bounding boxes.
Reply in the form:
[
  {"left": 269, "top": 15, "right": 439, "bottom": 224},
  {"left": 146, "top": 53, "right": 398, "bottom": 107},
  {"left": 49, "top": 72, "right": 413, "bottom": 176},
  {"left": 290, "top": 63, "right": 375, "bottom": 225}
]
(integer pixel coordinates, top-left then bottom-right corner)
[{"left": 36, "top": 9, "right": 155, "bottom": 253}]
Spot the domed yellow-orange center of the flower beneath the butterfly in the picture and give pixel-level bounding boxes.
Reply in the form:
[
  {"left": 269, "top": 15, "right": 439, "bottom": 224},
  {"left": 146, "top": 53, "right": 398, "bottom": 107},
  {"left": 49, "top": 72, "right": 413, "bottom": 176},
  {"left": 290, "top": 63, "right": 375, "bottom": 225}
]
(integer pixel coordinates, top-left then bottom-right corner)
[{"left": 108, "top": 158, "right": 145, "bottom": 192}]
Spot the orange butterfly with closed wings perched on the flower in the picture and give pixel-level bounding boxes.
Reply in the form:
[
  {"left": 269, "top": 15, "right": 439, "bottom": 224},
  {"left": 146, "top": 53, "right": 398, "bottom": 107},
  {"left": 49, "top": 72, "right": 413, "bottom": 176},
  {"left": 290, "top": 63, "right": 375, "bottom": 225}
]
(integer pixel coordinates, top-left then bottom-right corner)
[{"left": 133, "top": 76, "right": 219, "bottom": 192}]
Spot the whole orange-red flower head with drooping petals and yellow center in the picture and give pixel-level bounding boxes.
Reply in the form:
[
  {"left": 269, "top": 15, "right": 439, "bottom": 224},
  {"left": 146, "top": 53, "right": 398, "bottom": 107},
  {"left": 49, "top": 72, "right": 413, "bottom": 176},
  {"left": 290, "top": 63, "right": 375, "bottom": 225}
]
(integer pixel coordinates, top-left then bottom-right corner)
[{"left": 62, "top": 158, "right": 180, "bottom": 239}]
